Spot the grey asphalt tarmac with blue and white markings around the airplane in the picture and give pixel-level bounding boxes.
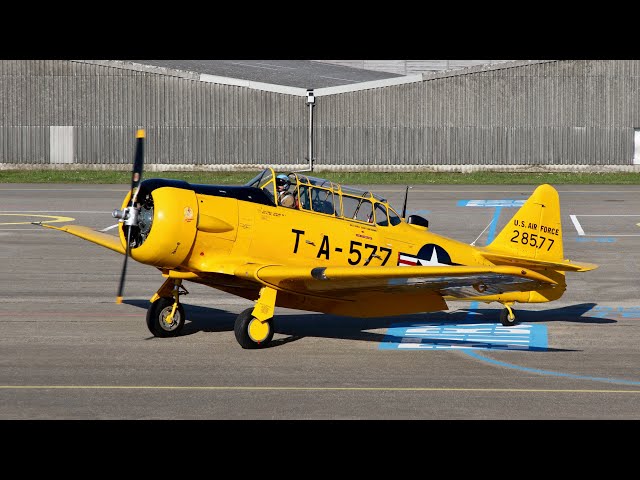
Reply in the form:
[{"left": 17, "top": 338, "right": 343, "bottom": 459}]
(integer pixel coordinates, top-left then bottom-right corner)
[{"left": 0, "top": 184, "right": 640, "bottom": 420}]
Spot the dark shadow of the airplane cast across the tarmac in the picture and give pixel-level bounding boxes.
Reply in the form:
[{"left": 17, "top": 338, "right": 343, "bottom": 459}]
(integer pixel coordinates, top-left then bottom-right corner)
[{"left": 125, "top": 300, "right": 616, "bottom": 352}]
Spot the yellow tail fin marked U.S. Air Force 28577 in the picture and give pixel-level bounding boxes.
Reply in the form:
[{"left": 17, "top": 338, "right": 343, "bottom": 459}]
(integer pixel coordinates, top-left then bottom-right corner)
[{"left": 486, "top": 184, "right": 564, "bottom": 263}]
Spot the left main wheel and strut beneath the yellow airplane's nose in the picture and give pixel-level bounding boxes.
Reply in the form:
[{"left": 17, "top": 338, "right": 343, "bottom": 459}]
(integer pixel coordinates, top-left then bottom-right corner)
[{"left": 147, "top": 278, "right": 189, "bottom": 338}]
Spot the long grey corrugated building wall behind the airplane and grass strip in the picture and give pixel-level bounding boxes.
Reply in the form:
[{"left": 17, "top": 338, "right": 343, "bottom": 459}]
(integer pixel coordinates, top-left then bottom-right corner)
[{"left": 0, "top": 60, "right": 640, "bottom": 171}]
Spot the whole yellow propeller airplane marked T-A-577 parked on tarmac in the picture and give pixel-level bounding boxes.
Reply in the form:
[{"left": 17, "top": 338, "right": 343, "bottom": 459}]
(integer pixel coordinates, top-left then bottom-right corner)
[{"left": 36, "top": 130, "right": 597, "bottom": 348}]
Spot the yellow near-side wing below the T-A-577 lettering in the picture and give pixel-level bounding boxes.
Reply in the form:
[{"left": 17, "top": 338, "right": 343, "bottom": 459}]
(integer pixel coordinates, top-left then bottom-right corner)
[{"left": 234, "top": 264, "right": 557, "bottom": 298}]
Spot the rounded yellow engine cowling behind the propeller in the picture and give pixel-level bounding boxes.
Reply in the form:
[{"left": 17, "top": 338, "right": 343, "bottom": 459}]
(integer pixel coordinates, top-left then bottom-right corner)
[{"left": 118, "top": 182, "right": 198, "bottom": 268}]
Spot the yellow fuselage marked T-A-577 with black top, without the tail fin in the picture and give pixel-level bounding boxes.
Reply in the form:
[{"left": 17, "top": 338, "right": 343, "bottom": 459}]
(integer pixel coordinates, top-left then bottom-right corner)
[{"left": 120, "top": 169, "right": 561, "bottom": 316}]
